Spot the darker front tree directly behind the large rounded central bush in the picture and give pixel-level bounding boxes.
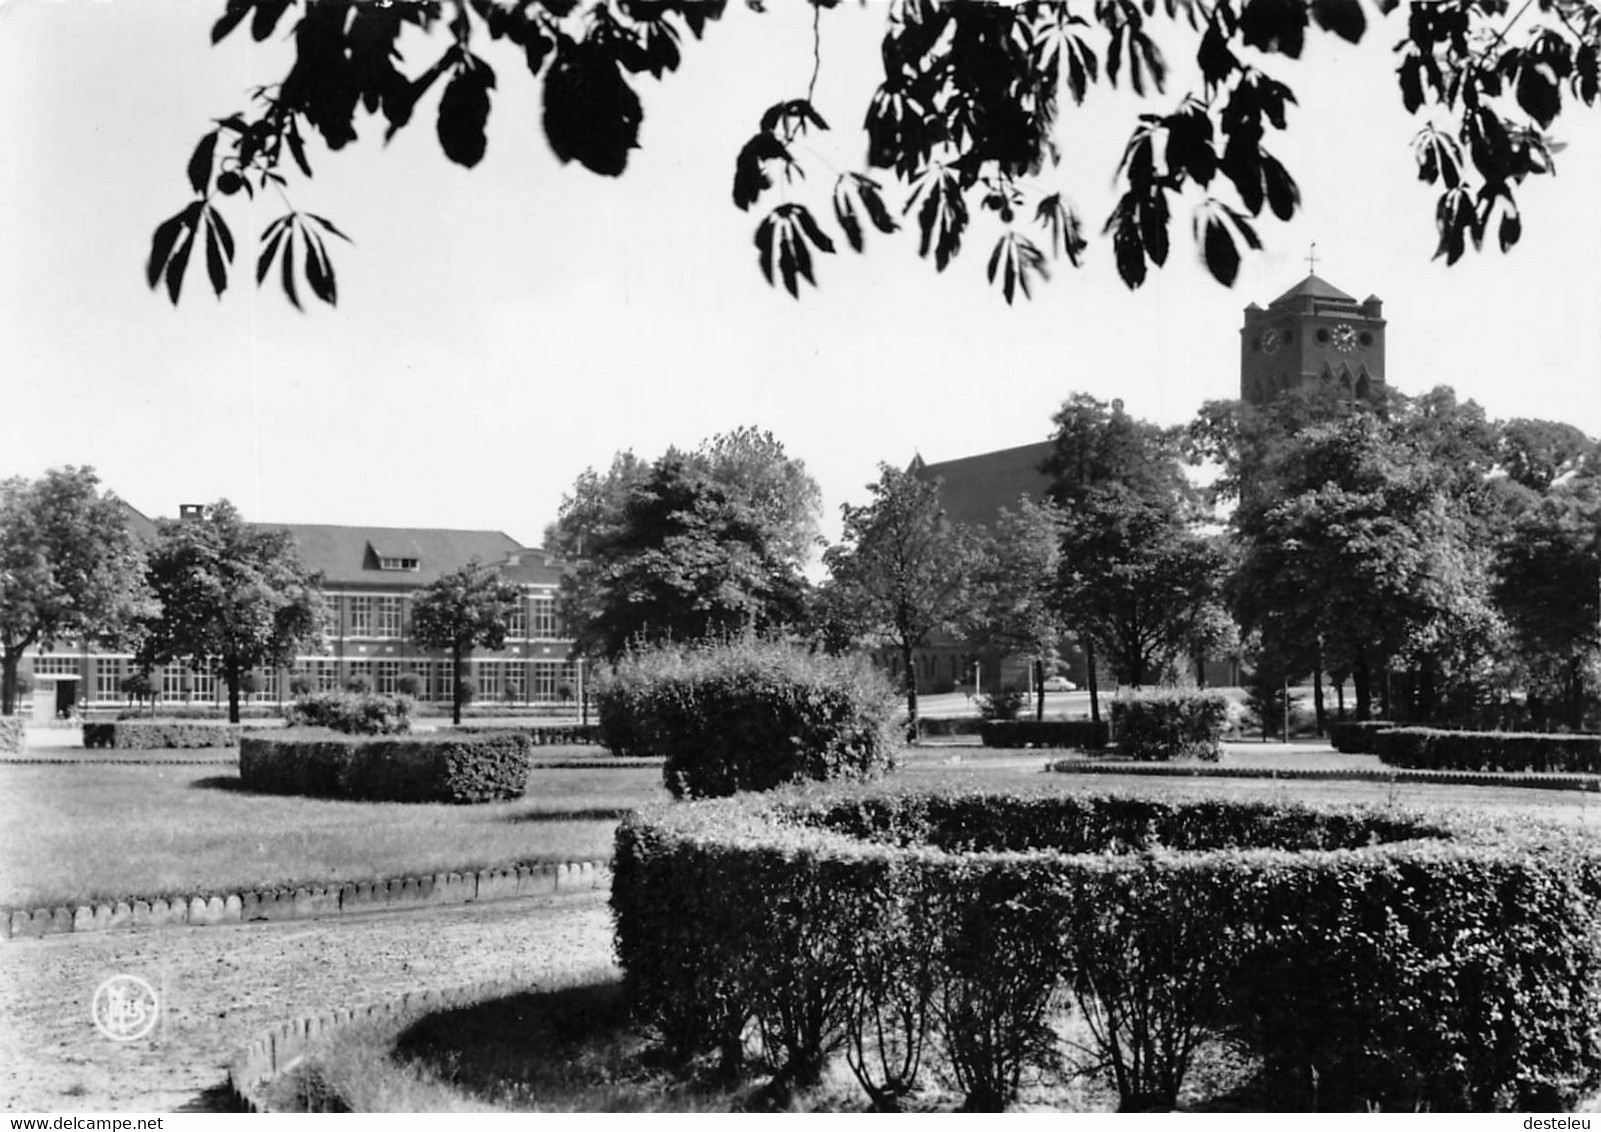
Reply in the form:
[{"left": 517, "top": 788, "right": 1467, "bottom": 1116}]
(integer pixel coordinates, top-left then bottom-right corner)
[{"left": 559, "top": 453, "right": 805, "bottom": 660}]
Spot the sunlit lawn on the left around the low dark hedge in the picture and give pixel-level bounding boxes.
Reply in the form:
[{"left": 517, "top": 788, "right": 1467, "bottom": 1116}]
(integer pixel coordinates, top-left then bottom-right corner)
[{"left": 0, "top": 748, "right": 666, "bottom": 906}]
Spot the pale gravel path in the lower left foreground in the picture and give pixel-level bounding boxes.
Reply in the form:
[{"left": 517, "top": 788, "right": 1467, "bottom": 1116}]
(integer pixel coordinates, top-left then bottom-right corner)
[{"left": 0, "top": 892, "right": 612, "bottom": 1113}]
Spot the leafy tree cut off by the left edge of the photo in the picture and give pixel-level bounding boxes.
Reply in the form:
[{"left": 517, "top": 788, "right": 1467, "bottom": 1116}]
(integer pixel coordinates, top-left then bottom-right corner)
[{"left": 0, "top": 468, "right": 152, "bottom": 716}]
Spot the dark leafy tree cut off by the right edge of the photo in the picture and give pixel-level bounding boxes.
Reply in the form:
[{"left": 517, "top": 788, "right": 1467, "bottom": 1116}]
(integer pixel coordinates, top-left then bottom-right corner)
[{"left": 1495, "top": 479, "right": 1601, "bottom": 730}]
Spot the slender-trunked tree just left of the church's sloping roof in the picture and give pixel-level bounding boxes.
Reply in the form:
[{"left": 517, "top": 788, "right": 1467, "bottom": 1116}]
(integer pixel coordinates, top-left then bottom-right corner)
[{"left": 823, "top": 464, "right": 978, "bottom": 735}]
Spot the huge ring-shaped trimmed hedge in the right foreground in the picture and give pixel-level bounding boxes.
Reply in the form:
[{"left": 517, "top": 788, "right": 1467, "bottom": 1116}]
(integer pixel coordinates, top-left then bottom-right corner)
[{"left": 612, "top": 786, "right": 1601, "bottom": 1111}]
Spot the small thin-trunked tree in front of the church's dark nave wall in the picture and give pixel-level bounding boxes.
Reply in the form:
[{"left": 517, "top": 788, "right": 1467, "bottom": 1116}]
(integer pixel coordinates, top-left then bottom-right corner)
[{"left": 967, "top": 495, "right": 1063, "bottom": 719}]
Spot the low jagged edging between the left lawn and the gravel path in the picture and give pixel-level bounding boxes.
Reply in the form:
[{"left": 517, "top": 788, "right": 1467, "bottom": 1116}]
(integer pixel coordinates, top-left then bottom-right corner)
[{"left": 0, "top": 861, "right": 612, "bottom": 940}]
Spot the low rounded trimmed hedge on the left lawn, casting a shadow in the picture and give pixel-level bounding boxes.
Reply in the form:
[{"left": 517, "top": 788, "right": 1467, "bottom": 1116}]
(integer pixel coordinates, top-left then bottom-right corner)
[{"left": 239, "top": 732, "right": 533, "bottom": 802}]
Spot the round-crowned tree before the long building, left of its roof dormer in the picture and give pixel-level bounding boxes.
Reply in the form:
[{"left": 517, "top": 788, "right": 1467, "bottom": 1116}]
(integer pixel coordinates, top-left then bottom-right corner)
[{"left": 139, "top": 500, "right": 322, "bottom": 724}]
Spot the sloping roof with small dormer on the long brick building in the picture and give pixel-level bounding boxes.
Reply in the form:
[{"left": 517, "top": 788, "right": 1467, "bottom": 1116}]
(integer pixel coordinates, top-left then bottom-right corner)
[{"left": 272, "top": 524, "right": 528, "bottom": 586}]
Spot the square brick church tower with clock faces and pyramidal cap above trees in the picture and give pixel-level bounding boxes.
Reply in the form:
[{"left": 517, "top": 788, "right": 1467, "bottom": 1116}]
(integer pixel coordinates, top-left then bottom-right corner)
[{"left": 1239, "top": 275, "right": 1385, "bottom": 405}]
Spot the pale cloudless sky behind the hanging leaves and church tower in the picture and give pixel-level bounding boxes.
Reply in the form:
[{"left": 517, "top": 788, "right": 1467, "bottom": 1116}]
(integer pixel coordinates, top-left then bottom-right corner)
[{"left": 0, "top": 0, "right": 1601, "bottom": 557}]
